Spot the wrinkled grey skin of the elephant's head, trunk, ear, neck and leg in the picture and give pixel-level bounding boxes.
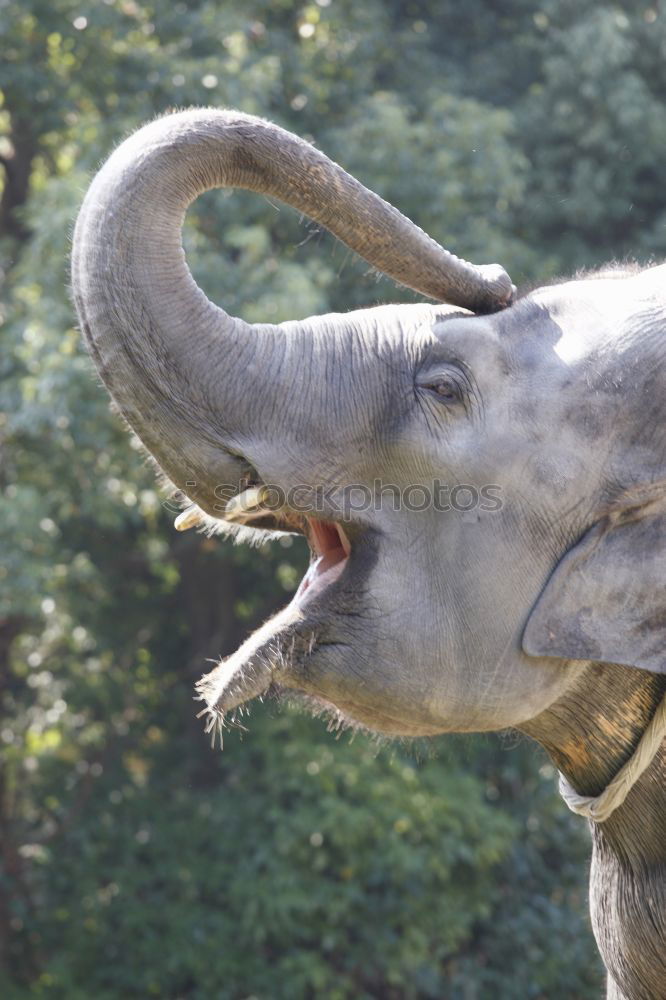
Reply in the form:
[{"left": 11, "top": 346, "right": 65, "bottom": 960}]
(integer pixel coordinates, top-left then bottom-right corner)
[{"left": 73, "top": 109, "right": 666, "bottom": 1000}]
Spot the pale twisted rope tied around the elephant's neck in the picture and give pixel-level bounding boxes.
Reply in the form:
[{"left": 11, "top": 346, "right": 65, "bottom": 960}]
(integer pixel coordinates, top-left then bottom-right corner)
[{"left": 560, "top": 695, "right": 666, "bottom": 823}]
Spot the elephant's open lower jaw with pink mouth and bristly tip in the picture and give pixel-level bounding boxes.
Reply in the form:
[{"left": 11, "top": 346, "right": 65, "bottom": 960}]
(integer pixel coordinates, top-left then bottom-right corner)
[{"left": 196, "top": 517, "right": 351, "bottom": 742}]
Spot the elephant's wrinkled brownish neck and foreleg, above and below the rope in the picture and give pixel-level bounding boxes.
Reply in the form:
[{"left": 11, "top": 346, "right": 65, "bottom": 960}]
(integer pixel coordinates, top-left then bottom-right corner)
[{"left": 520, "top": 663, "right": 666, "bottom": 1000}]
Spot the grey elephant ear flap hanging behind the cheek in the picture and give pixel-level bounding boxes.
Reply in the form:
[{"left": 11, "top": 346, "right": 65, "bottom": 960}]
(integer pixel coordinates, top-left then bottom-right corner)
[{"left": 523, "top": 511, "right": 666, "bottom": 674}]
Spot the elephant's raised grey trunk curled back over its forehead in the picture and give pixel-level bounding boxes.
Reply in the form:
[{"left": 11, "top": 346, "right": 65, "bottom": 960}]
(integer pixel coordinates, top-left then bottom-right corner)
[{"left": 72, "top": 109, "right": 512, "bottom": 513}]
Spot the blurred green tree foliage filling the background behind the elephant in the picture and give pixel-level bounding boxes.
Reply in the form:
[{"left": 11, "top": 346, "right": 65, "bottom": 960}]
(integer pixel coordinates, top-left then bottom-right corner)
[{"left": 0, "top": 0, "right": 666, "bottom": 1000}]
